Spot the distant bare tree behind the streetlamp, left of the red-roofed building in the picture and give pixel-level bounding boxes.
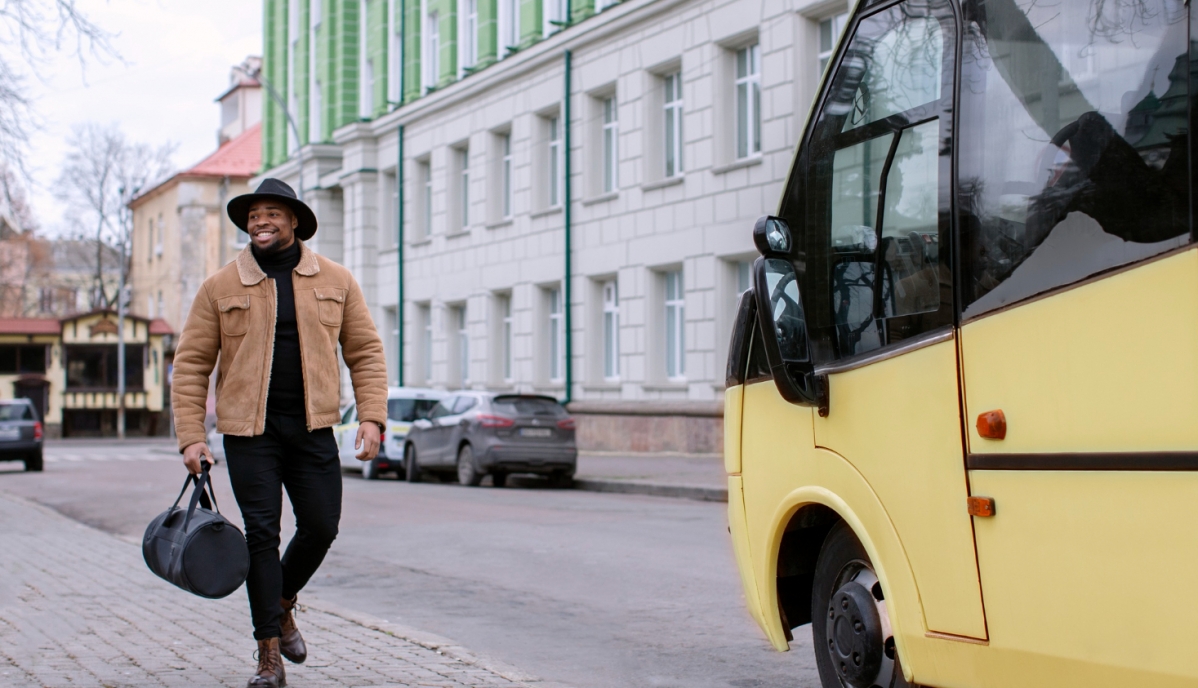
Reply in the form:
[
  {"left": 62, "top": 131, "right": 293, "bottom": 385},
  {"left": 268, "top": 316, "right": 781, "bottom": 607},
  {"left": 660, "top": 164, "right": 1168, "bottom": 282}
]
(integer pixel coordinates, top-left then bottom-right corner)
[{"left": 55, "top": 123, "right": 176, "bottom": 308}]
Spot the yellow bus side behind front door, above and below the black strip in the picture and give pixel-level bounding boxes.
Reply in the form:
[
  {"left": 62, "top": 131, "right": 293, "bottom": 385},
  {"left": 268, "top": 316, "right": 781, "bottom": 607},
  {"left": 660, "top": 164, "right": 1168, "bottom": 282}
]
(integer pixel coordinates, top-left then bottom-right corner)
[{"left": 961, "top": 249, "right": 1198, "bottom": 684}]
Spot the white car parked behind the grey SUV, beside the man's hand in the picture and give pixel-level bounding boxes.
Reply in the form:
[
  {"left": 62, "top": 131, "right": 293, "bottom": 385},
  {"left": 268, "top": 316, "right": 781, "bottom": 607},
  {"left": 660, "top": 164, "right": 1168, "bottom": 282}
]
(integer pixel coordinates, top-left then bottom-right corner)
[{"left": 333, "top": 387, "right": 446, "bottom": 481}]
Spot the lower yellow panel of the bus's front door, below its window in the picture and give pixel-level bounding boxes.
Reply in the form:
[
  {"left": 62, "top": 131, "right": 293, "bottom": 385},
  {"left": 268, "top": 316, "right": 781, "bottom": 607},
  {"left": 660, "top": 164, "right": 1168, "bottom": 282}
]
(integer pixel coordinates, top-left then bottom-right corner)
[{"left": 815, "top": 340, "right": 986, "bottom": 639}]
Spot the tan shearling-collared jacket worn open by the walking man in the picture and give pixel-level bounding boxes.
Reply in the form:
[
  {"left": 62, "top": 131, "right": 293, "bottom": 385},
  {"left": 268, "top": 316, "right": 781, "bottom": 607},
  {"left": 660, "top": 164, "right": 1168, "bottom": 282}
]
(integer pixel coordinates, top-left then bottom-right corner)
[{"left": 170, "top": 240, "right": 387, "bottom": 451}]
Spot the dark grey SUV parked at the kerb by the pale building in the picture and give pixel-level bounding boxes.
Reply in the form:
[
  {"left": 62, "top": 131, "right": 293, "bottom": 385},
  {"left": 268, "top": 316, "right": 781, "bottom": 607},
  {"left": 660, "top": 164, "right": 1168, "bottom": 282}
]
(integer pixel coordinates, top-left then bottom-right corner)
[{"left": 404, "top": 392, "right": 579, "bottom": 487}]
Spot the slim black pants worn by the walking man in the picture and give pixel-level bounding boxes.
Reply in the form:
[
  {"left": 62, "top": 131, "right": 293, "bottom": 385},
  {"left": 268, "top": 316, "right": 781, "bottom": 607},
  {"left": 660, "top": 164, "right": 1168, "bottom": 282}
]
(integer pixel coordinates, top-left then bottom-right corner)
[{"left": 224, "top": 414, "right": 341, "bottom": 640}]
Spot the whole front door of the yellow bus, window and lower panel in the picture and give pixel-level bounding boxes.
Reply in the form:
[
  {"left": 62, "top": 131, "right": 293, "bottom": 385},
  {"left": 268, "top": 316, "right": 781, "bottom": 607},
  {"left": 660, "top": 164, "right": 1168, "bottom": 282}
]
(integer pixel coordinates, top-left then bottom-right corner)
[{"left": 758, "top": 0, "right": 986, "bottom": 638}]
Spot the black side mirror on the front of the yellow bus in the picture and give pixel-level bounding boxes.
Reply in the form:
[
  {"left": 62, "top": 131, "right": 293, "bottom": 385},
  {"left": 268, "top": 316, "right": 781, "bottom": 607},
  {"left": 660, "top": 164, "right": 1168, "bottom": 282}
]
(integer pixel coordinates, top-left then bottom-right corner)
[{"left": 754, "top": 217, "right": 828, "bottom": 415}]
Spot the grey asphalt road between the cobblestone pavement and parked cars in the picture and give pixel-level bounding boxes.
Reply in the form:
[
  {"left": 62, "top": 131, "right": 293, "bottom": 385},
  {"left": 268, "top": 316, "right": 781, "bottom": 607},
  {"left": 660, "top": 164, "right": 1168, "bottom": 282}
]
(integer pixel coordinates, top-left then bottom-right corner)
[{"left": 0, "top": 442, "right": 818, "bottom": 688}]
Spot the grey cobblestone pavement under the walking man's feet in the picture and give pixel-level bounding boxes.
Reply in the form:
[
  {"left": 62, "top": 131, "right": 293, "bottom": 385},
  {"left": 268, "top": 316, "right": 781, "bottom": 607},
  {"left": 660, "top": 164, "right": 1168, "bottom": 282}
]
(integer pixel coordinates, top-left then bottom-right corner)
[{"left": 0, "top": 494, "right": 546, "bottom": 688}]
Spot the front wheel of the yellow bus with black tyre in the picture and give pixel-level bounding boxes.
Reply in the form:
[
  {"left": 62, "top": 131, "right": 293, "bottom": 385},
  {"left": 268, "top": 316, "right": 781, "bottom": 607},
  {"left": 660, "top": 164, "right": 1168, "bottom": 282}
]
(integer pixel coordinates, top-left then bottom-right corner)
[{"left": 811, "top": 523, "right": 912, "bottom": 688}]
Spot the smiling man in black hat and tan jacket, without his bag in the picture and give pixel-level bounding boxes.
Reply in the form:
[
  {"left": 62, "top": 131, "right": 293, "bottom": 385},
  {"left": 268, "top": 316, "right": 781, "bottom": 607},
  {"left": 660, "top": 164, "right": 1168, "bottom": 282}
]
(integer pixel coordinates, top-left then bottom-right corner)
[{"left": 171, "top": 179, "right": 387, "bottom": 688}]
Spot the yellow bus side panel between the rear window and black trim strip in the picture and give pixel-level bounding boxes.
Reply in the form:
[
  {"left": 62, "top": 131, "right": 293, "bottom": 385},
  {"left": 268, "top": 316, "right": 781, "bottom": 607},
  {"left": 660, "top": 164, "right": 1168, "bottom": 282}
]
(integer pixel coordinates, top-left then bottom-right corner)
[{"left": 961, "top": 249, "right": 1198, "bottom": 454}]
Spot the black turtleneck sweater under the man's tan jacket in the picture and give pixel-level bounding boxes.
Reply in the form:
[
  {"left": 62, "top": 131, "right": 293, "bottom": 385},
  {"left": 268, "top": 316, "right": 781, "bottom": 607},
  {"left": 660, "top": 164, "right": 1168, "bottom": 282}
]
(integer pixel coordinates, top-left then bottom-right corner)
[{"left": 254, "top": 241, "right": 304, "bottom": 416}]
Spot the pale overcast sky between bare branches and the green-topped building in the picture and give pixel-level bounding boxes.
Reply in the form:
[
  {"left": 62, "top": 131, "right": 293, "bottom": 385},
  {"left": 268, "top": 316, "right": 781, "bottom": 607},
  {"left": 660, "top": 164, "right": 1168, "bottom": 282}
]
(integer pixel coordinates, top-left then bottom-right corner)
[{"left": 29, "top": 0, "right": 262, "bottom": 234}]
